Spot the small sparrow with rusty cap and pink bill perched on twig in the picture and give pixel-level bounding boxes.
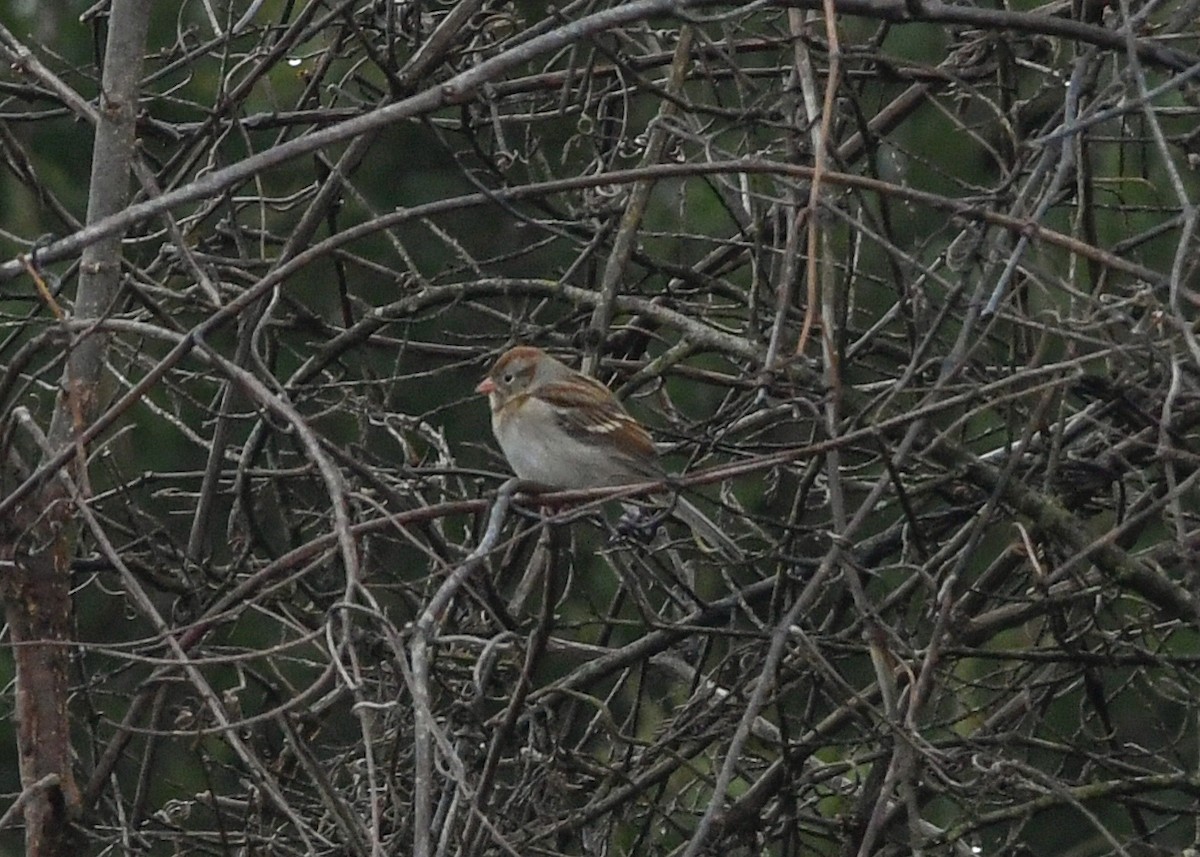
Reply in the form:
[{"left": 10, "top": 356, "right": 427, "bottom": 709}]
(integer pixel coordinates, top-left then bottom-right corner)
[{"left": 475, "top": 346, "right": 742, "bottom": 559}]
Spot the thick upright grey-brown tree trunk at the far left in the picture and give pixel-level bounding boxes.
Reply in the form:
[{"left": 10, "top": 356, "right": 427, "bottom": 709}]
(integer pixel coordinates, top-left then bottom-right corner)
[{"left": 0, "top": 0, "right": 152, "bottom": 857}]
